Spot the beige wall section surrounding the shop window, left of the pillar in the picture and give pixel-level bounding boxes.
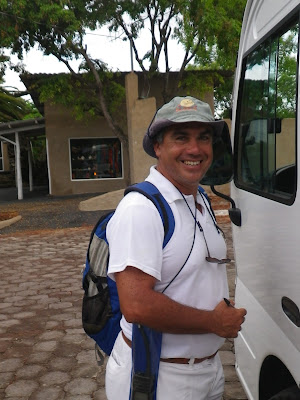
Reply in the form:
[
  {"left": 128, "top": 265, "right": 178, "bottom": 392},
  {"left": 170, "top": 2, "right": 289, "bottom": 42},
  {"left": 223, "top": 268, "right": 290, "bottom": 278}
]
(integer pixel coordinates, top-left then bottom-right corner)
[{"left": 45, "top": 103, "right": 128, "bottom": 196}]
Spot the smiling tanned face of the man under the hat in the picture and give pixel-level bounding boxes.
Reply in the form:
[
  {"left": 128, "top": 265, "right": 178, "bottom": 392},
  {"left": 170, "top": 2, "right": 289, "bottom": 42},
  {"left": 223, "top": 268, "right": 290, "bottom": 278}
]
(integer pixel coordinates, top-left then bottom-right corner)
[{"left": 154, "top": 122, "right": 213, "bottom": 195}]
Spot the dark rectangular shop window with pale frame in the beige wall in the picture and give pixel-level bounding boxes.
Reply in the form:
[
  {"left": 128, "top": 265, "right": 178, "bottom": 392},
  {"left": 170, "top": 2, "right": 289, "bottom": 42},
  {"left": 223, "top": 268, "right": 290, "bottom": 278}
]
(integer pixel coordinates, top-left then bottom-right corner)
[{"left": 70, "top": 138, "right": 122, "bottom": 180}]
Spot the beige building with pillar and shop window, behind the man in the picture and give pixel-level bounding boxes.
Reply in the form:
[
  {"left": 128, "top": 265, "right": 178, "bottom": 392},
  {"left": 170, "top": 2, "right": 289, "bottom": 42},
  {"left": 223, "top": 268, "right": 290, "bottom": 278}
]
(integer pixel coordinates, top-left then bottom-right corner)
[{"left": 2, "top": 72, "right": 225, "bottom": 196}]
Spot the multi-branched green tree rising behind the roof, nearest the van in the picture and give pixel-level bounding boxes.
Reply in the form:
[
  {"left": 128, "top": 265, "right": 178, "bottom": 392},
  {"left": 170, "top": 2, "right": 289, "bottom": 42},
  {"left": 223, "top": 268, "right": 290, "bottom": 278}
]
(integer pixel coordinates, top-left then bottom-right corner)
[{"left": 98, "top": 0, "right": 246, "bottom": 101}]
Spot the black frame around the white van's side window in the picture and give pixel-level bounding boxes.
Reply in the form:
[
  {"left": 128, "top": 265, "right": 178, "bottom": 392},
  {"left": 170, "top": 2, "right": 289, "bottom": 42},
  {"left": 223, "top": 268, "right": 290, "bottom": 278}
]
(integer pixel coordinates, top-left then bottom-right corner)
[{"left": 233, "top": 13, "right": 300, "bottom": 205}]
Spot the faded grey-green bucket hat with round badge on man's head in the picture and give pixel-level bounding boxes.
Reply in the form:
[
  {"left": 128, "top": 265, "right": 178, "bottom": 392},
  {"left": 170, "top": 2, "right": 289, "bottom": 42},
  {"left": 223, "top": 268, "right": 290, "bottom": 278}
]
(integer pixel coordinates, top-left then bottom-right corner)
[{"left": 143, "top": 96, "right": 224, "bottom": 158}]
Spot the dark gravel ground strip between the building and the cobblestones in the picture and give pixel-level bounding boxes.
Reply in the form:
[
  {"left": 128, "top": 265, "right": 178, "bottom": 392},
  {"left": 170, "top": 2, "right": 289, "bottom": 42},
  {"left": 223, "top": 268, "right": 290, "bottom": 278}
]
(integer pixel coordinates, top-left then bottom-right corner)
[{"left": 0, "top": 189, "right": 108, "bottom": 234}]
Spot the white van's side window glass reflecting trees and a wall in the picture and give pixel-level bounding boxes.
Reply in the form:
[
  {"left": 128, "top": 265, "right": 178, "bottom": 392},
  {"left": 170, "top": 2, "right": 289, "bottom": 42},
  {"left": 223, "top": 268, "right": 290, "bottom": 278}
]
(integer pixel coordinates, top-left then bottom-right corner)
[{"left": 235, "top": 19, "right": 299, "bottom": 203}]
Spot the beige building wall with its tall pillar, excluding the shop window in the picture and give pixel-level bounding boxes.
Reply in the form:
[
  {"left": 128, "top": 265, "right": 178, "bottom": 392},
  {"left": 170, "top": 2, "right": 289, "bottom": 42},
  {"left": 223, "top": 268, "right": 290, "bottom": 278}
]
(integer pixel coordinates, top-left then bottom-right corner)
[{"left": 45, "top": 73, "right": 227, "bottom": 196}]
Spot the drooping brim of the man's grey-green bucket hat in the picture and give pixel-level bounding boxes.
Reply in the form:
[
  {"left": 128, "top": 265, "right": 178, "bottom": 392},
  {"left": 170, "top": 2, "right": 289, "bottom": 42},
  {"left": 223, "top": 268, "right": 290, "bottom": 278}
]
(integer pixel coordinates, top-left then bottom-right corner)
[{"left": 143, "top": 119, "right": 226, "bottom": 158}]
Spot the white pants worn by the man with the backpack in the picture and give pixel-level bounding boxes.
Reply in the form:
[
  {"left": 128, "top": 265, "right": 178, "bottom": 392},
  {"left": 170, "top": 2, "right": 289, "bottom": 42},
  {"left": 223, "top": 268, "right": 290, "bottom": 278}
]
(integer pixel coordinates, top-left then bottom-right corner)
[{"left": 105, "top": 333, "right": 224, "bottom": 400}]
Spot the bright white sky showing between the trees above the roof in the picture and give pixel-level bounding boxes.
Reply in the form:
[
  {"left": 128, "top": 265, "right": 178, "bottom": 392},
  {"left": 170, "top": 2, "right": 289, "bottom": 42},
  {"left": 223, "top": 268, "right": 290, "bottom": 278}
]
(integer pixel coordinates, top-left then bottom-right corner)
[{"left": 3, "top": 28, "right": 183, "bottom": 94}]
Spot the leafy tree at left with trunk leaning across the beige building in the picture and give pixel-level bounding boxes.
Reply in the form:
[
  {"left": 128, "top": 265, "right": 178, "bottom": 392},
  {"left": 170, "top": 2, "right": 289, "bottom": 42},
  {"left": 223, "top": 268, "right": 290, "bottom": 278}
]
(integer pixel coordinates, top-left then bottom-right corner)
[{"left": 0, "top": 0, "right": 127, "bottom": 145}]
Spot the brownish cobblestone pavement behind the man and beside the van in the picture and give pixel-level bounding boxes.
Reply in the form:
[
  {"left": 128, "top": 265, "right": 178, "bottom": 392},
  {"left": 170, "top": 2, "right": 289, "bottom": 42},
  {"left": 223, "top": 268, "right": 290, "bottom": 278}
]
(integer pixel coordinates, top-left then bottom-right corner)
[{"left": 0, "top": 223, "right": 246, "bottom": 400}]
